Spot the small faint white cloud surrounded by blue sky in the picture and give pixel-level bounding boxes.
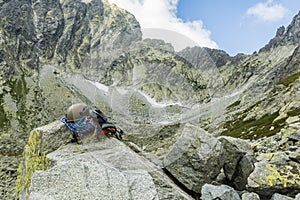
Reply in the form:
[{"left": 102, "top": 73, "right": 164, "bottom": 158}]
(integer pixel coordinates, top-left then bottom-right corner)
[{"left": 246, "top": 0, "right": 288, "bottom": 22}]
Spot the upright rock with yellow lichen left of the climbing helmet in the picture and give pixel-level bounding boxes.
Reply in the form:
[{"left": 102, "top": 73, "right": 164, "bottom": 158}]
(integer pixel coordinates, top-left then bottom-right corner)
[{"left": 16, "top": 121, "right": 72, "bottom": 198}]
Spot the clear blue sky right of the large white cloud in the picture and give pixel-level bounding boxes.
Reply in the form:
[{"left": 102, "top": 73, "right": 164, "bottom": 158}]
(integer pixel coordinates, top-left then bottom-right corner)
[{"left": 177, "top": 0, "right": 300, "bottom": 55}]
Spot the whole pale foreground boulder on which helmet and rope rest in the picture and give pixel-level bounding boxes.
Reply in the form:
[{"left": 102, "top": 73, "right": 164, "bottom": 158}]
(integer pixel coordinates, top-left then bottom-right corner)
[{"left": 19, "top": 121, "right": 193, "bottom": 200}]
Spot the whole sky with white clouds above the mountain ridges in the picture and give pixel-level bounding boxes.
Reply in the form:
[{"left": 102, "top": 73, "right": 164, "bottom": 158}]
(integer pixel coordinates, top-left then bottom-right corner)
[{"left": 108, "top": 0, "right": 300, "bottom": 56}]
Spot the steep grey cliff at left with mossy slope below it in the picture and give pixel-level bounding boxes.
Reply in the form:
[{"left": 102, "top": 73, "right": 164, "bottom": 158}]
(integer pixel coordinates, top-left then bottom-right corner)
[{"left": 0, "top": 0, "right": 141, "bottom": 199}]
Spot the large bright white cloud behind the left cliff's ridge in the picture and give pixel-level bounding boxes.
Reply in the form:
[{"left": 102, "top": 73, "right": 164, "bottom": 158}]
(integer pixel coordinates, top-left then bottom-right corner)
[{"left": 108, "top": 0, "right": 218, "bottom": 51}]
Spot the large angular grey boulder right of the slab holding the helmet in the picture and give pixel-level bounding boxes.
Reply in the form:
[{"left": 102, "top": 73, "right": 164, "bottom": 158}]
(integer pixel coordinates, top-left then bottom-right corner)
[{"left": 163, "top": 124, "right": 224, "bottom": 193}]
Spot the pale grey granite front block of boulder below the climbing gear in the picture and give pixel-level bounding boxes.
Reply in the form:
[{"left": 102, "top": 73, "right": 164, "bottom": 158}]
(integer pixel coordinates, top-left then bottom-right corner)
[{"left": 29, "top": 148, "right": 158, "bottom": 200}]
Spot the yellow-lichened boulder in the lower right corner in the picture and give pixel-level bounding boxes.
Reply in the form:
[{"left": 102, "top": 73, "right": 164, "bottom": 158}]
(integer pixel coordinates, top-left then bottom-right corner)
[{"left": 247, "top": 153, "right": 300, "bottom": 198}]
